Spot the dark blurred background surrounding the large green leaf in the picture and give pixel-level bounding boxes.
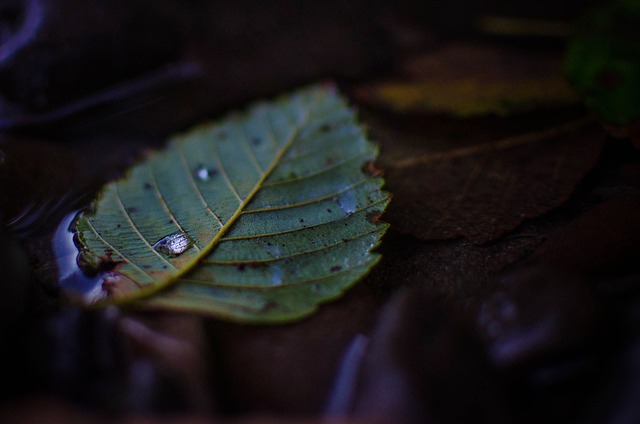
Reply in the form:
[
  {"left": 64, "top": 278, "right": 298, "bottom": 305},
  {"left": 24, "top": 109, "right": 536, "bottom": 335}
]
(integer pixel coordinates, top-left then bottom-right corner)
[{"left": 0, "top": 0, "right": 640, "bottom": 423}]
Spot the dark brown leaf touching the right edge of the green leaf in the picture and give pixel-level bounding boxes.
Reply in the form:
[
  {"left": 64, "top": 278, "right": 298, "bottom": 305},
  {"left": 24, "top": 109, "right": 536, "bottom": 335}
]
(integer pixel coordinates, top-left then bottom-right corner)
[{"left": 382, "top": 120, "right": 605, "bottom": 244}]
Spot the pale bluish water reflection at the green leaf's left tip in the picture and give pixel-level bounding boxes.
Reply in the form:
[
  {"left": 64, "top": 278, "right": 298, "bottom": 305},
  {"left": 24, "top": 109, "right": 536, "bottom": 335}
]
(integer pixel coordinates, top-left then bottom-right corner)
[{"left": 53, "top": 211, "right": 106, "bottom": 303}]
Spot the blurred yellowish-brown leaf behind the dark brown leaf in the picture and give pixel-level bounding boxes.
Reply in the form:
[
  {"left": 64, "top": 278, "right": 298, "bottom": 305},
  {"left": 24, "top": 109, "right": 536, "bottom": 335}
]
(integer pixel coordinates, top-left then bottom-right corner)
[{"left": 360, "top": 43, "right": 578, "bottom": 117}]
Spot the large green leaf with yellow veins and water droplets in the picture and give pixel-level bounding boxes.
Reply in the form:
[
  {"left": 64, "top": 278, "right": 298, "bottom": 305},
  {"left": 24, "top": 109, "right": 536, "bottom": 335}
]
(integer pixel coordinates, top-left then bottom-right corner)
[{"left": 76, "top": 86, "right": 389, "bottom": 322}]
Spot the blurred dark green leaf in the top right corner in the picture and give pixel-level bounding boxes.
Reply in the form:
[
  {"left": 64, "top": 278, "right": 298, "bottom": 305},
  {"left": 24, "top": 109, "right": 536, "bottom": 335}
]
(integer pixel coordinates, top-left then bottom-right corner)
[{"left": 565, "top": 1, "right": 640, "bottom": 126}]
